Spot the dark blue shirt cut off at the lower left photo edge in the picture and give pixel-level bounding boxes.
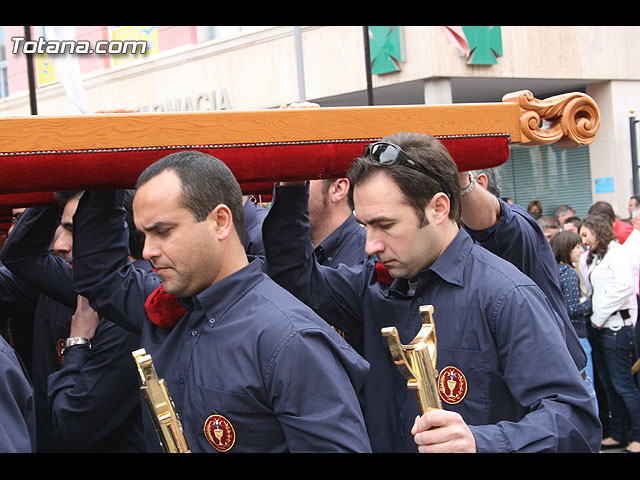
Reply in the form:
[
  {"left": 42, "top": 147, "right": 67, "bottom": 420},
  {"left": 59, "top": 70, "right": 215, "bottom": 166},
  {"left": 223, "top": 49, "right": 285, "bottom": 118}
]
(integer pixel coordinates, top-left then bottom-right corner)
[{"left": 0, "top": 332, "right": 36, "bottom": 453}]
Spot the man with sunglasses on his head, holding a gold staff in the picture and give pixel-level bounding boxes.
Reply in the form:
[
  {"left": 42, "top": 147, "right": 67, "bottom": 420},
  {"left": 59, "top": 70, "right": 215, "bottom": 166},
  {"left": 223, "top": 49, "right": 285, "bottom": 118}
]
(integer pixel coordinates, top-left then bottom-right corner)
[{"left": 263, "top": 133, "right": 601, "bottom": 452}]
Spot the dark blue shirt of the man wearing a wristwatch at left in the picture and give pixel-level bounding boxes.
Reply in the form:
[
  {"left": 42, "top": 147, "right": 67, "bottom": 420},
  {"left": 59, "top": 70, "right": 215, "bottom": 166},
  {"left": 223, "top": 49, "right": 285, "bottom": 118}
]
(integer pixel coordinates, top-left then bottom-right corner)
[{"left": 2, "top": 207, "right": 142, "bottom": 452}]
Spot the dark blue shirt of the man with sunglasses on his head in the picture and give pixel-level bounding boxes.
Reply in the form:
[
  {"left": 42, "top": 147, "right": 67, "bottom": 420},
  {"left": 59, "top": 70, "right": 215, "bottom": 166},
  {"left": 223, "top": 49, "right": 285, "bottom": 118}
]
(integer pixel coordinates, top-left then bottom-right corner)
[{"left": 263, "top": 182, "right": 601, "bottom": 452}]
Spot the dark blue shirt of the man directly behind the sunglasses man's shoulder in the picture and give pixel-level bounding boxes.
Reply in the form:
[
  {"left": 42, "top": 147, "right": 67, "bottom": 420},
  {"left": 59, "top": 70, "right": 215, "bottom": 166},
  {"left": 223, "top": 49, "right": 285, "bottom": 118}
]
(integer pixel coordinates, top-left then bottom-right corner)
[{"left": 466, "top": 198, "right": 587, "bottom": 370}]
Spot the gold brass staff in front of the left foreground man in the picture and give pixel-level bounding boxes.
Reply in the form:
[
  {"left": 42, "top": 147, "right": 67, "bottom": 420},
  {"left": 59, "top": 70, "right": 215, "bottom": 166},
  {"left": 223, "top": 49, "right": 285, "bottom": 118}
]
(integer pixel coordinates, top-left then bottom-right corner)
[{"left": 131, "top": 348, "right": 190, "bottom": 453}]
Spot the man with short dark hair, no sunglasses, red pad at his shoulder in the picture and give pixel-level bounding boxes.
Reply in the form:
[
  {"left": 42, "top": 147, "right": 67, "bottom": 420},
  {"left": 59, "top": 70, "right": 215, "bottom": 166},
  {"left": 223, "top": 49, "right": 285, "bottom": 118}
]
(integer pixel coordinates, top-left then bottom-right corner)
[{"left": 74, "top": 151, "right": 370, "bottom": 453}]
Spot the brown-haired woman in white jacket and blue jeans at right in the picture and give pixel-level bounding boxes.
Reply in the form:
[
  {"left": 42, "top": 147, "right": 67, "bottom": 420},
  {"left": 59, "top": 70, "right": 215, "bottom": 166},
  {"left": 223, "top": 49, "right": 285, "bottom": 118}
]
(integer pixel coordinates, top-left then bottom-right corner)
[{"left": 579, "top": 215, "right": 640, "bottom": 453}]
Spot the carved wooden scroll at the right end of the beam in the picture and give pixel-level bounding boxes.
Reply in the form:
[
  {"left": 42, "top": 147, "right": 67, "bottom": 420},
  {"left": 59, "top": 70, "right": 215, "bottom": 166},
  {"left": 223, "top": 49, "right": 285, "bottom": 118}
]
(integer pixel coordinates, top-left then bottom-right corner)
[{"left": 502, "top": 90, "right": 600, "bottom": 148}]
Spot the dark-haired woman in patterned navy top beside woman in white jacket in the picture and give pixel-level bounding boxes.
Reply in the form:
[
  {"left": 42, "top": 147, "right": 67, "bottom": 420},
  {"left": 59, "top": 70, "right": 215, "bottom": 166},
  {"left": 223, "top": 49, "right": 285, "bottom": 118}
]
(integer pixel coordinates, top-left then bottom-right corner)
[{"left": 549, "top": 231, "right": 598, "bottom": 409}]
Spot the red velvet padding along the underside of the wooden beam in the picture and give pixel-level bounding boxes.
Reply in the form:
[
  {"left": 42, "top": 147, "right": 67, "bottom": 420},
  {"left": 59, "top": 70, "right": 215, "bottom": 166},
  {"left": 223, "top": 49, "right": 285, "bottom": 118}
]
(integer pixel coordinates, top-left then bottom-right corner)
[{"left": 0, "top": 136, "right": 509, "bottom": 194}]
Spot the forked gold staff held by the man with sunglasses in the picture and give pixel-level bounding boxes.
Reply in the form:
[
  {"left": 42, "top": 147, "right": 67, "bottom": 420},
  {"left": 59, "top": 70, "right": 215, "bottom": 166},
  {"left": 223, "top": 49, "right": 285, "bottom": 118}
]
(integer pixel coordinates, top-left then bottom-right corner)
[{"left": 382, "top": 305, "right": 442, "bottom": 415}]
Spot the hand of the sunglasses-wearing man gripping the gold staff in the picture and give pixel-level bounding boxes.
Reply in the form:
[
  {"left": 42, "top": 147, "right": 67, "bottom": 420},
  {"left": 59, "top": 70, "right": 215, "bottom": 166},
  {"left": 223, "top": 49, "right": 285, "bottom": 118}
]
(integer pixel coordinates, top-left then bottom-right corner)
[{"left": 411, "top": 409, "right": 477, "bottom": 453}]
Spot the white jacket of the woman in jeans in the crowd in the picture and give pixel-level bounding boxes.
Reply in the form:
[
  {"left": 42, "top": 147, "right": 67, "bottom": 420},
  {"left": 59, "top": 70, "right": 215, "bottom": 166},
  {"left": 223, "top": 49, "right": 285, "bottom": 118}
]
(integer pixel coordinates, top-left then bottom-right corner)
[{"left": 589, "top": 240, "right": 638, "bottom": 329}]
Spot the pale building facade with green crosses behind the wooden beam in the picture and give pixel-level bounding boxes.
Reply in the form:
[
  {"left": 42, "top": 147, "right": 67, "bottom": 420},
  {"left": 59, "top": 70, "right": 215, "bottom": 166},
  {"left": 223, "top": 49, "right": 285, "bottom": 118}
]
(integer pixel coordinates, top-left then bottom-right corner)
[{"left": 0, "top": 26, "right": 640, "bottom": 218}]
